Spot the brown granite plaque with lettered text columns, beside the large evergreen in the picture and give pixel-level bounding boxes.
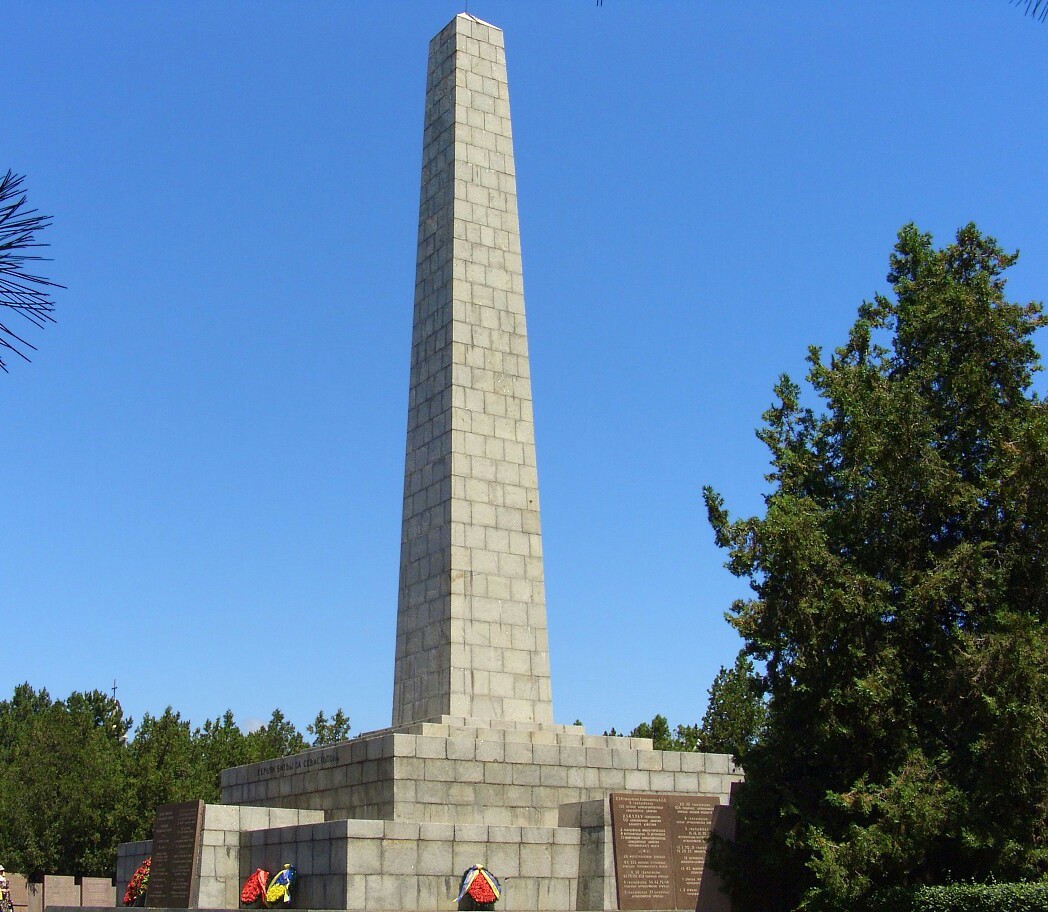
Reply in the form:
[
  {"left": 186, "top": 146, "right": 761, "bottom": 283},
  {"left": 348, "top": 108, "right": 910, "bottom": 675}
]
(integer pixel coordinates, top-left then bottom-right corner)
[{"left": 611, "top": 792, "right": 719, "bottom": 910}]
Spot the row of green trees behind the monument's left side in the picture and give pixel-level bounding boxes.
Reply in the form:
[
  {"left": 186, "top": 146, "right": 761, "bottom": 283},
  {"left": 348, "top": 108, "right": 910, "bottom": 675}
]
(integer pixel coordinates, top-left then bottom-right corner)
[{"left": 0, "top": 683, "right": 350, "bottom": 877}]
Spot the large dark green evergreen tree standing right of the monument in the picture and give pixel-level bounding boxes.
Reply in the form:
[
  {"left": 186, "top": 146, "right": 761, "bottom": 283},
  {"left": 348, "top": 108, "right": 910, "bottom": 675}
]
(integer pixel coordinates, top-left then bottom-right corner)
[{"left": 705, "top": 225, "right": 1048, "bottom": 912}]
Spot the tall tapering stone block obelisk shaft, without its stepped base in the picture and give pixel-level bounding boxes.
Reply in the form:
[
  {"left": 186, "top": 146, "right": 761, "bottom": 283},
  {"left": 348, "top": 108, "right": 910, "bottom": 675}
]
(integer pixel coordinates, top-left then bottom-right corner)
[{"left": 393, "top": 14, "right": 553, "bottom": 725}]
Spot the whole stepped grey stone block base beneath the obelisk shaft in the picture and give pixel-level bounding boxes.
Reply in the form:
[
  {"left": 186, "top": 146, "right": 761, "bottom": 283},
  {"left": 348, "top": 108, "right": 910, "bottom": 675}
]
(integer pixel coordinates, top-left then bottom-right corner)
[{"left": 117, "top": 718, "right": 742, "bottom": 912}]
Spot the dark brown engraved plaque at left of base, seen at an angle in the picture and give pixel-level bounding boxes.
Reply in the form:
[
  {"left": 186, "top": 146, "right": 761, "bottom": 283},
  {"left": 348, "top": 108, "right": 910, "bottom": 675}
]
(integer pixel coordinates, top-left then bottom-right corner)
[{"left": 146, "top": 801, "right": 203, "bottom": 909}]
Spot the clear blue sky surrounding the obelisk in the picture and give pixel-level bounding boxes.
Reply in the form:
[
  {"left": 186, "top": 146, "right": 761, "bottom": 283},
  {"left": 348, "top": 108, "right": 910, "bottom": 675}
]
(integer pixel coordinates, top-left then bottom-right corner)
[{"left": 0, "top": 0, "right": 1048, "bottom": 732}]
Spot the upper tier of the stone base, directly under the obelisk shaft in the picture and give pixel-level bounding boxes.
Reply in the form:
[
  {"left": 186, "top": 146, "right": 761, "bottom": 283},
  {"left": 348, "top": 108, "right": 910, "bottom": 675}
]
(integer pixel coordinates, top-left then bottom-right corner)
[{"left": 222, "top": 717, "right": 740, "bottom": 830}]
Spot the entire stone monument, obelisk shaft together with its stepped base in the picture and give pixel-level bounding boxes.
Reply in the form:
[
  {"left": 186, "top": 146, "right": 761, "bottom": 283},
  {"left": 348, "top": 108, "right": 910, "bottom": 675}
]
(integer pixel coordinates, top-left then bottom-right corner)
[{"left": 194, "top": 21, "right": 741, "bottom": 912}]
